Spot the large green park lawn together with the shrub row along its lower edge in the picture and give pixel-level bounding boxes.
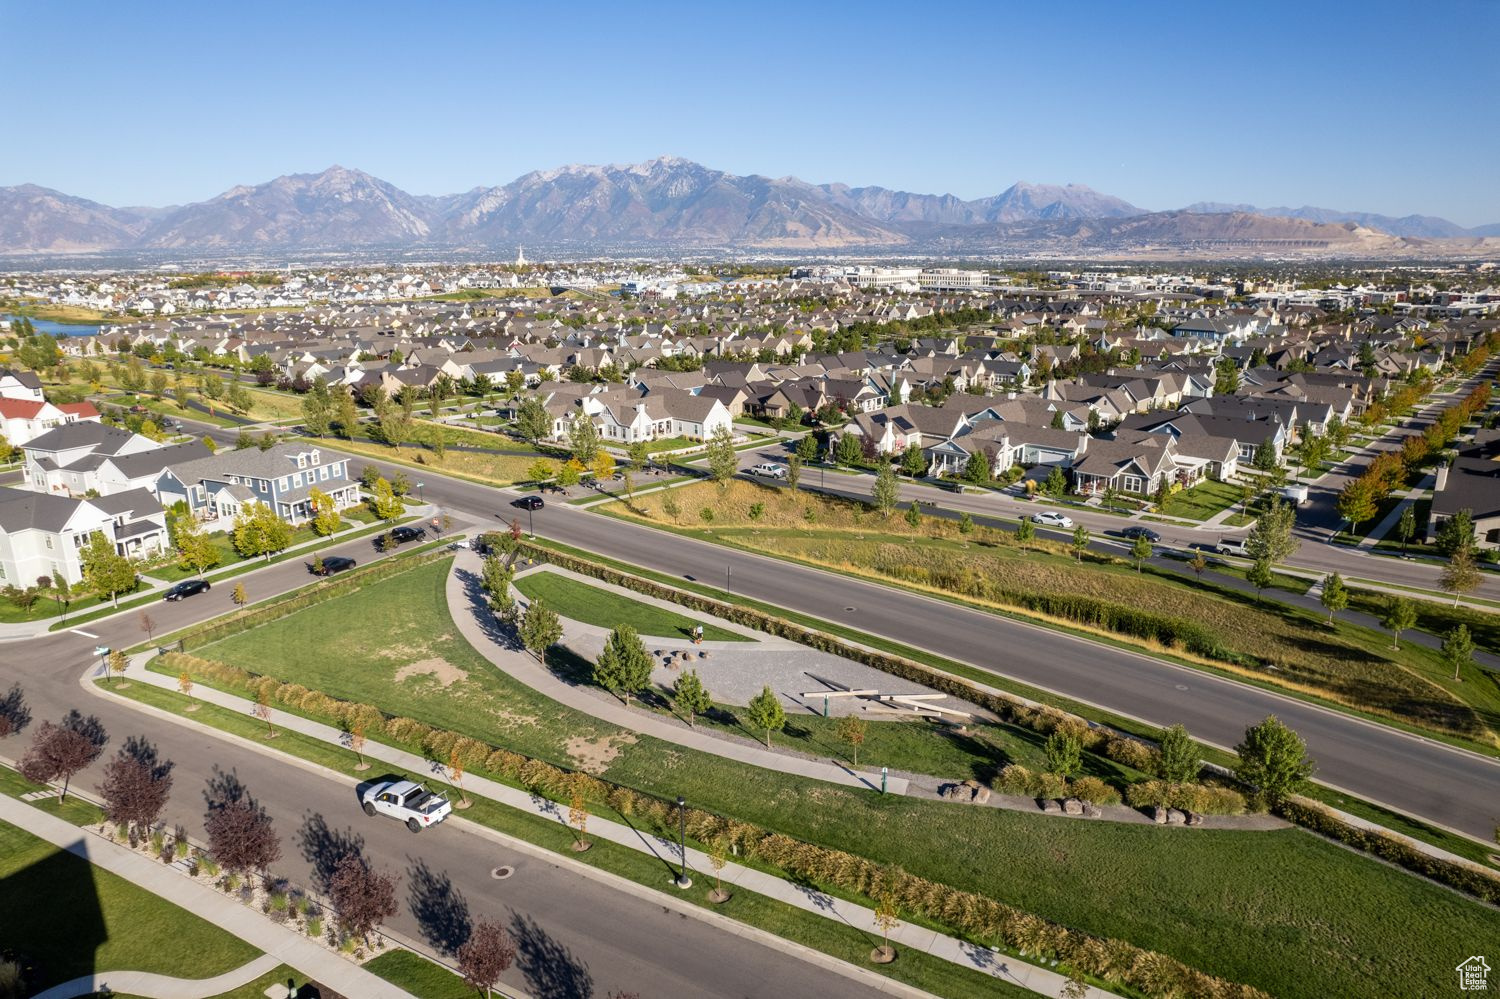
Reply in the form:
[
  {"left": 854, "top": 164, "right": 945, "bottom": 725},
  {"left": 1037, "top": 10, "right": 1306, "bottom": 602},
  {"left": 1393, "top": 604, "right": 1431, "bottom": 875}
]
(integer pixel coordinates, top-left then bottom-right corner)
[{"left": 111, "top": 549, "right": 1496, "bottom": 995}]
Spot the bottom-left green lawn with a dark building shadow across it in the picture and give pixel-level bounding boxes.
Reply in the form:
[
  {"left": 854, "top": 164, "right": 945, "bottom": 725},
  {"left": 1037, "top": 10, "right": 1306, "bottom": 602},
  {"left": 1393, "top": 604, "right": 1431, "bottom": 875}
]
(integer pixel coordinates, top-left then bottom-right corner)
[{"left": 0, "top": 822, "right": 260, "bottom": 992}]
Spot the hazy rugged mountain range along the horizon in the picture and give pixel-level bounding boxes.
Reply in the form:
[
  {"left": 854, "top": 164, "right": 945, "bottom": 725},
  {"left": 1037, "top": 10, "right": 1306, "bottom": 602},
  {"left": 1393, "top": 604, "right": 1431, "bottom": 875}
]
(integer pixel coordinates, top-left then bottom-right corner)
[{"left": 0, "top": 158, "right": 1500, "bottom": 255}]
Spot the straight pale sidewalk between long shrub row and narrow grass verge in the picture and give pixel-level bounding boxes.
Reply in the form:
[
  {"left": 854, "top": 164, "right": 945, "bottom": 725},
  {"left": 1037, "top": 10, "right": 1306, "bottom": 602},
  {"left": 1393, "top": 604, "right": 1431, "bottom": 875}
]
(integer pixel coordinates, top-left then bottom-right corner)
[{"left": 102, "top": 653, "right": 1092, "bottom": 999}]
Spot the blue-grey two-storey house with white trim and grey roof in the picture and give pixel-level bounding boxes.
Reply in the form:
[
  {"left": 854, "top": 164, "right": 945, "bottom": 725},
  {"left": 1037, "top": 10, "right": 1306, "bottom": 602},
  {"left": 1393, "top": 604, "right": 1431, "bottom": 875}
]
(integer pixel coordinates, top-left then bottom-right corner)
[{"left": 155, "top": 444, "right": 360, "bottom": 530}]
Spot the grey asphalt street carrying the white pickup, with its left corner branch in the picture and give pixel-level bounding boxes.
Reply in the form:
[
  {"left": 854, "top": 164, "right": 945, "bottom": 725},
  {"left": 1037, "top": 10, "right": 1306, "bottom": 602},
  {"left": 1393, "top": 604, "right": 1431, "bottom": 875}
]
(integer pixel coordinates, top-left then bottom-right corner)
[{"left": 0, "top": 525, "right": 867, "bottom": 999}]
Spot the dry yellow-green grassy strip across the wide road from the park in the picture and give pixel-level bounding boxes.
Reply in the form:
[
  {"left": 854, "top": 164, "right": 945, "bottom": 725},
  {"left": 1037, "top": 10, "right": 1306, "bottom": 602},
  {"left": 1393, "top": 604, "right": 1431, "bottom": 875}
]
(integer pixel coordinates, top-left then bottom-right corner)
[{"left": 594, "top": 482, "right": 1500, "bottom": 755}]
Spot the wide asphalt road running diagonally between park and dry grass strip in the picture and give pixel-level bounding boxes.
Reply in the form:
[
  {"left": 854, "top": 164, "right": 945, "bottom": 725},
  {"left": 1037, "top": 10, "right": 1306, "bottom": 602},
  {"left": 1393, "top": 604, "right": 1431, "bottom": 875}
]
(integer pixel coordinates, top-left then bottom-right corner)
[{"left": 301, "top": 447, "right": 1500, "bottom": 842}]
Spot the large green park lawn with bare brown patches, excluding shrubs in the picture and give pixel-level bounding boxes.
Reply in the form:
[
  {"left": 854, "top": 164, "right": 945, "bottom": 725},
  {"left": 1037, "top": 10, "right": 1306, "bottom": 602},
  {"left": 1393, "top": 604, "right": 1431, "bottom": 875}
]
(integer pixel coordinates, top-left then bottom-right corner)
[{"left": 146, "top": 563, "right": 1497, "bottom": 995}]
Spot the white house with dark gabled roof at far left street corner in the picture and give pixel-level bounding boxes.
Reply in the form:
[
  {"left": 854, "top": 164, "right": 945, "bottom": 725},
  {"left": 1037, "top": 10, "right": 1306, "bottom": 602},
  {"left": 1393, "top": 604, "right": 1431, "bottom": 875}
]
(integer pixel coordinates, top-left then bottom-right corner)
[{"left": 0, "top": 486, "right": 167, "bottom": 588}]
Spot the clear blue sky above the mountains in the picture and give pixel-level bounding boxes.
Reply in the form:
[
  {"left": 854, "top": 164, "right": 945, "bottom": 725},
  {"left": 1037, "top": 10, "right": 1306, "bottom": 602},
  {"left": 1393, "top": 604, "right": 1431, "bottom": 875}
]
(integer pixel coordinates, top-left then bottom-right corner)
[{"left": 0, "top": 0, "right": 1500, "bottom": 225}]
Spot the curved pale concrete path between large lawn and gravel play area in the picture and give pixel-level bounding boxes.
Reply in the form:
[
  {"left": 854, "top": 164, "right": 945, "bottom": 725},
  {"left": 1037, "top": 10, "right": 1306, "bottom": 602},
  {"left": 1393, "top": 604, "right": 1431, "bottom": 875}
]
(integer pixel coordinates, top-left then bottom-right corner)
[{"left": 459, "top": 551, "right": 906, "bottom": 795}]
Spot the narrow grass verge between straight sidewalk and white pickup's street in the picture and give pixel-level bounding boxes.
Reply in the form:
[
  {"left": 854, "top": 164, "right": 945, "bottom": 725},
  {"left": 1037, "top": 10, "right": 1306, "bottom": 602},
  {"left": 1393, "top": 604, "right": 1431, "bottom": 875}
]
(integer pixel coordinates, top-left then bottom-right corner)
[{"left": 98, "top": 681, "right": 1031, "bottom": 999}]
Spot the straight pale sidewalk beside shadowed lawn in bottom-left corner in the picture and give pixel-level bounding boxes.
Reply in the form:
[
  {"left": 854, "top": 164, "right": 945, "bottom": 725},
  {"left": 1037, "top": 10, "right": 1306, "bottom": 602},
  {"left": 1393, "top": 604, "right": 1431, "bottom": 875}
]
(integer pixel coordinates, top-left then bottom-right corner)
[{"left": 0, "top": 792, "right": 411, "bottom": 999}]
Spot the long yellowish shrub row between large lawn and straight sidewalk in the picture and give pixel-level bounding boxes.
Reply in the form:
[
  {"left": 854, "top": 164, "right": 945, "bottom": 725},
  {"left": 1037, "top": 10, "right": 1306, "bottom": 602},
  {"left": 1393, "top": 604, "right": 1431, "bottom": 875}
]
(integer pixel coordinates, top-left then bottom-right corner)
[{"left": 162, "top": 653, "right": 1265, "bottom": 999}]
